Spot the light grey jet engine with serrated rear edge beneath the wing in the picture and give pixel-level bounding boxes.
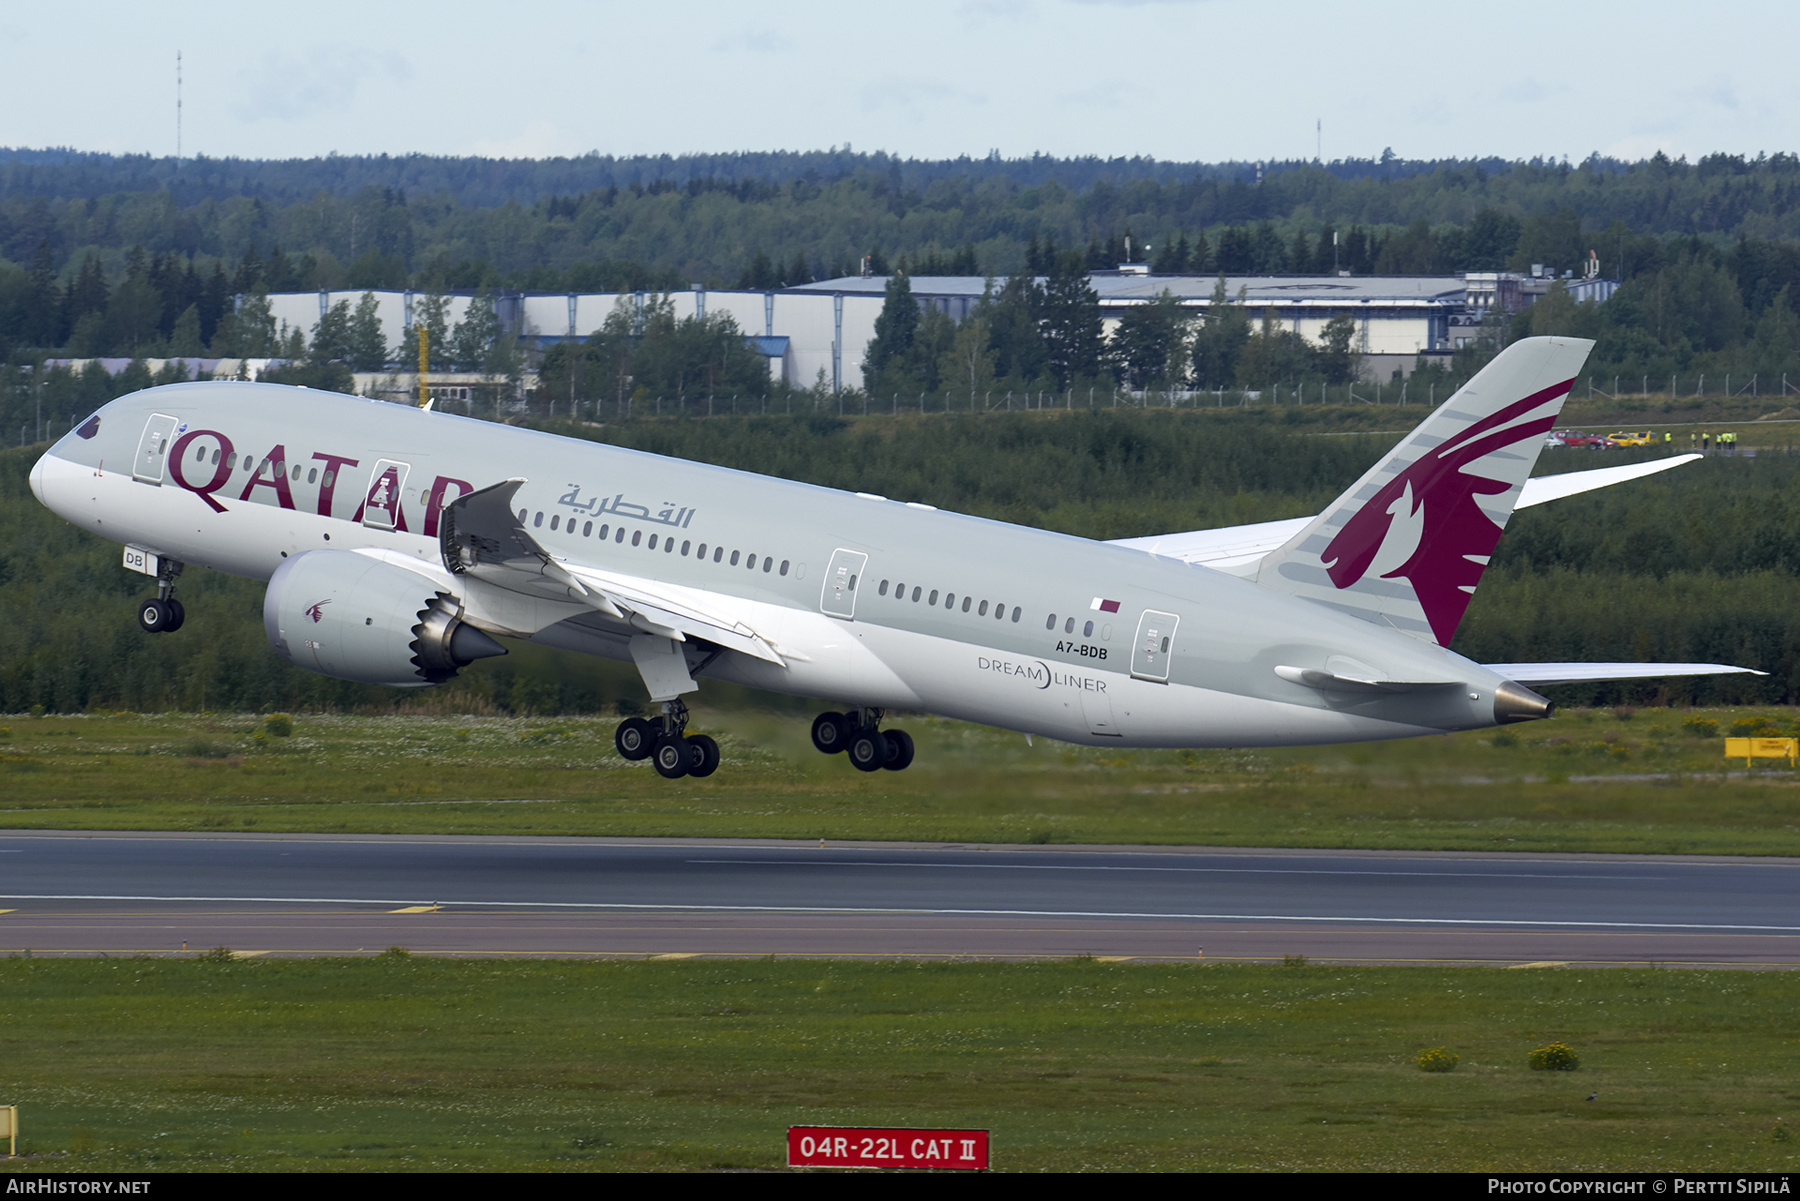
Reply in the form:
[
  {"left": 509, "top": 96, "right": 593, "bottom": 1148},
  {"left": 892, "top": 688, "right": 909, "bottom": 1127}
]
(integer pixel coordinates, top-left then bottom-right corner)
[{"left": 263, "top": 551, "right": 506, "bottom": 688}]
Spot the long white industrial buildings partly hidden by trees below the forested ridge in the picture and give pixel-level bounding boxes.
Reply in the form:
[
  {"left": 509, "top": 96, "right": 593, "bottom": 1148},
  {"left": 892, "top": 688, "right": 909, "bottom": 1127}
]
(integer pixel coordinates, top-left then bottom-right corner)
[{"left": 239, "top": 265, "right": 1618, "bottom": 391}]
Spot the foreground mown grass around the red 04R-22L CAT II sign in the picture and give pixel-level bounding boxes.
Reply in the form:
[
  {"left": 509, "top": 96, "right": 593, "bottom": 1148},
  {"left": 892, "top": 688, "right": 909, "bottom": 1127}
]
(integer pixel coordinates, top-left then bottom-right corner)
[{"left": 0, "top": 954, "right": 1800, "bottom": 1172}]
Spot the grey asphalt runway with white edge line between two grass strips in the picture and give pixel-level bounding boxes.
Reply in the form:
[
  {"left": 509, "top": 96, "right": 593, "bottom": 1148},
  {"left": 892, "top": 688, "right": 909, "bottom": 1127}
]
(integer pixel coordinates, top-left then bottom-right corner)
[{"left": 0, "top": 832, "right": 1800, "bottom": 967}]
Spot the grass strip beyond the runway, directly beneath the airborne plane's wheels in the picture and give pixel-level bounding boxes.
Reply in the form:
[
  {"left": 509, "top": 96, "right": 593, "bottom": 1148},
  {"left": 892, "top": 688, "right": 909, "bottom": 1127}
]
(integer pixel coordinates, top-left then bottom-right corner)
[{"left": 0, "top": 709, "right": 1800, "bottom": 855}]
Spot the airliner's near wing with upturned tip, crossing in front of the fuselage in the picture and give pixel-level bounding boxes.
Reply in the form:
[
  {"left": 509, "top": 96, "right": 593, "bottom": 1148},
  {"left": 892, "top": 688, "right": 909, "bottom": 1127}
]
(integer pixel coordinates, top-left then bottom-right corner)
[{"left": 437, "top": 479, "right": 787, "bottom": 666}]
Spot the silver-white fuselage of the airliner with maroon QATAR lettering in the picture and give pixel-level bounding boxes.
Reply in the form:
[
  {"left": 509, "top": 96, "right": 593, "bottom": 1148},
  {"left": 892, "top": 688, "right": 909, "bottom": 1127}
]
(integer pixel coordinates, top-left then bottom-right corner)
[{"left": 32, "top": 384, "right": 1501, "bottom": 747}]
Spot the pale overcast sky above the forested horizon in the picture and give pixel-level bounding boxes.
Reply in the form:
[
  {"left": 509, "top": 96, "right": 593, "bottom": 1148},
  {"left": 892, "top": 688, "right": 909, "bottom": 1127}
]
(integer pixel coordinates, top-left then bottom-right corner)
[{"left": 0, "top": 0, "right": 1800, "bottom": 162}]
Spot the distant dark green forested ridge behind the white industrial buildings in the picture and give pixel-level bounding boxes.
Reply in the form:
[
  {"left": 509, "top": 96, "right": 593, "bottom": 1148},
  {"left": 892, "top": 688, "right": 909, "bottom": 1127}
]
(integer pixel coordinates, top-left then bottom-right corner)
[{"left": 10, "top": 151, "right": 1800, "bottom": 324}]
